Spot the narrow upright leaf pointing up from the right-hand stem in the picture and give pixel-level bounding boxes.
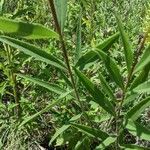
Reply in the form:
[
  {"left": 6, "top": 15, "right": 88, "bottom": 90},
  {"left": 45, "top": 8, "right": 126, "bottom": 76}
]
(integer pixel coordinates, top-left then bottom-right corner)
[{"left": 115, "top": 14, "right": 133, "bottom": 72}]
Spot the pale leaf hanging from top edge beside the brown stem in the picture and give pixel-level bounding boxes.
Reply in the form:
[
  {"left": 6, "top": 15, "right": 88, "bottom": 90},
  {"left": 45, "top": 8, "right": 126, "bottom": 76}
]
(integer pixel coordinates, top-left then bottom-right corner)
[{"left": 54, "top": 0, "right": 68, "bottom": 32}]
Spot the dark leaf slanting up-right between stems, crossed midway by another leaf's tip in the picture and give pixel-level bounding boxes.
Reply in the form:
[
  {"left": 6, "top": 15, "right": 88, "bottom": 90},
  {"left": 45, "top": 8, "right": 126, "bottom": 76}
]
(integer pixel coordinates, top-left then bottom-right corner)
[{"left": 76, "top": 33, "right": 119, "bottom": 67}]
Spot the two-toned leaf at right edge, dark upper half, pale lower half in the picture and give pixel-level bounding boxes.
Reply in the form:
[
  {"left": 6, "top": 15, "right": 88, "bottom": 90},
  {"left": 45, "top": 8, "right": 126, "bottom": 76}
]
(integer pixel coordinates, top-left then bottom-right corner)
[{"left": 126, "top": 97, "right": 150, "bottom": 120}]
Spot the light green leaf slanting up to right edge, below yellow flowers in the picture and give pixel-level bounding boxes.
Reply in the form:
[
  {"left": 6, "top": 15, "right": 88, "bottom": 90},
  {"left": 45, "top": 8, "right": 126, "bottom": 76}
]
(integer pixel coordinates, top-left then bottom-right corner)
[{"left": 134, "top": 45, "right": 150, "bottom": 73}]
